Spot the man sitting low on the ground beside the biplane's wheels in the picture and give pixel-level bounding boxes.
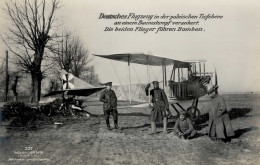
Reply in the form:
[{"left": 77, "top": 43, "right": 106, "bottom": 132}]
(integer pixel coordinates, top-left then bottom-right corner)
[{"left": 173, "top": 112, "right": 197, "bottom": 139}]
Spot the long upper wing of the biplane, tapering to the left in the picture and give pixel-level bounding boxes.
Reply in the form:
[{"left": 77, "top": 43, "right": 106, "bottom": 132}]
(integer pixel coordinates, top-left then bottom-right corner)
[{"left": 93, "top": 53, "right": 190, "bottom": 68}]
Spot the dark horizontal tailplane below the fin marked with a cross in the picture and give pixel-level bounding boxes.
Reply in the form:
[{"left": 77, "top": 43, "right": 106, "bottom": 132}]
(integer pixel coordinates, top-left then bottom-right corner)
[{"left": 43, "top": 87, "right": 105, "bottom": 97}]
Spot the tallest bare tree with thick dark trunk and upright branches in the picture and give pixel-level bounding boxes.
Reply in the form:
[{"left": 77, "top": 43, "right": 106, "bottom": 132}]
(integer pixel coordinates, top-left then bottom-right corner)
[{"left": 2, "top": 0, "right": 59, "bottom": 102}]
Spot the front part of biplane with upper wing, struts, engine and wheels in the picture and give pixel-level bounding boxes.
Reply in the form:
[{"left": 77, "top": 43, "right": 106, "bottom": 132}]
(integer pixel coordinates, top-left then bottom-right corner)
[{"left": 93, "top": 53, "right": 217, "bottom": 120}]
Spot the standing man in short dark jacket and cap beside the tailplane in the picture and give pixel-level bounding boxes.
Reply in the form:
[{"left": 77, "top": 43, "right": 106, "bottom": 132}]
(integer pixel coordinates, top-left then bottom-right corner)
[{"left": 99, "top": 82, "right": 119, "bottom": 130}]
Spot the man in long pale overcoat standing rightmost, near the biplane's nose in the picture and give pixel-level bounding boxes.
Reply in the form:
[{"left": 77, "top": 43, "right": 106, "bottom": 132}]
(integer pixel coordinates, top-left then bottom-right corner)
[{"left": 208, "top": 86, "right": 235, "bottom": 142}]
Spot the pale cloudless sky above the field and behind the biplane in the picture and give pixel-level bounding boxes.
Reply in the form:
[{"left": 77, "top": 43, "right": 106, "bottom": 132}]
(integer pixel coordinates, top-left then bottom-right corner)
[{"left": 0, "top": 0, "right": 260, "bottom": 92}]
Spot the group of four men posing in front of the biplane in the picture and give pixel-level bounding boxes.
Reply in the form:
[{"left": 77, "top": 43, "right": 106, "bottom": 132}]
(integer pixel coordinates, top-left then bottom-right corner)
[{"left": 100, "top": 81, "right": 235, "bottom": 141}]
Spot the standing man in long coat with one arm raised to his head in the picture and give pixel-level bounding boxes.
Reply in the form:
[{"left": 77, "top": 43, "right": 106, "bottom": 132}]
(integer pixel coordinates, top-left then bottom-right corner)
[{"left": 145, "top": 81, "right": 169, "bottom": 134}]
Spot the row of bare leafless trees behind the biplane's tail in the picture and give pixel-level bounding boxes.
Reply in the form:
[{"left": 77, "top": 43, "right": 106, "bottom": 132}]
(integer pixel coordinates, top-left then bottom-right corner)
[{"left": 0, "top": 0, "right": 99, "bottom": 103}]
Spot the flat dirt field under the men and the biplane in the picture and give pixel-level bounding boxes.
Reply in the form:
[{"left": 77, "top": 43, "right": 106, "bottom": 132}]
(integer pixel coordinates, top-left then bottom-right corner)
[{"left": 0, "top": 94, "right": 260, "bottom": 165}]
